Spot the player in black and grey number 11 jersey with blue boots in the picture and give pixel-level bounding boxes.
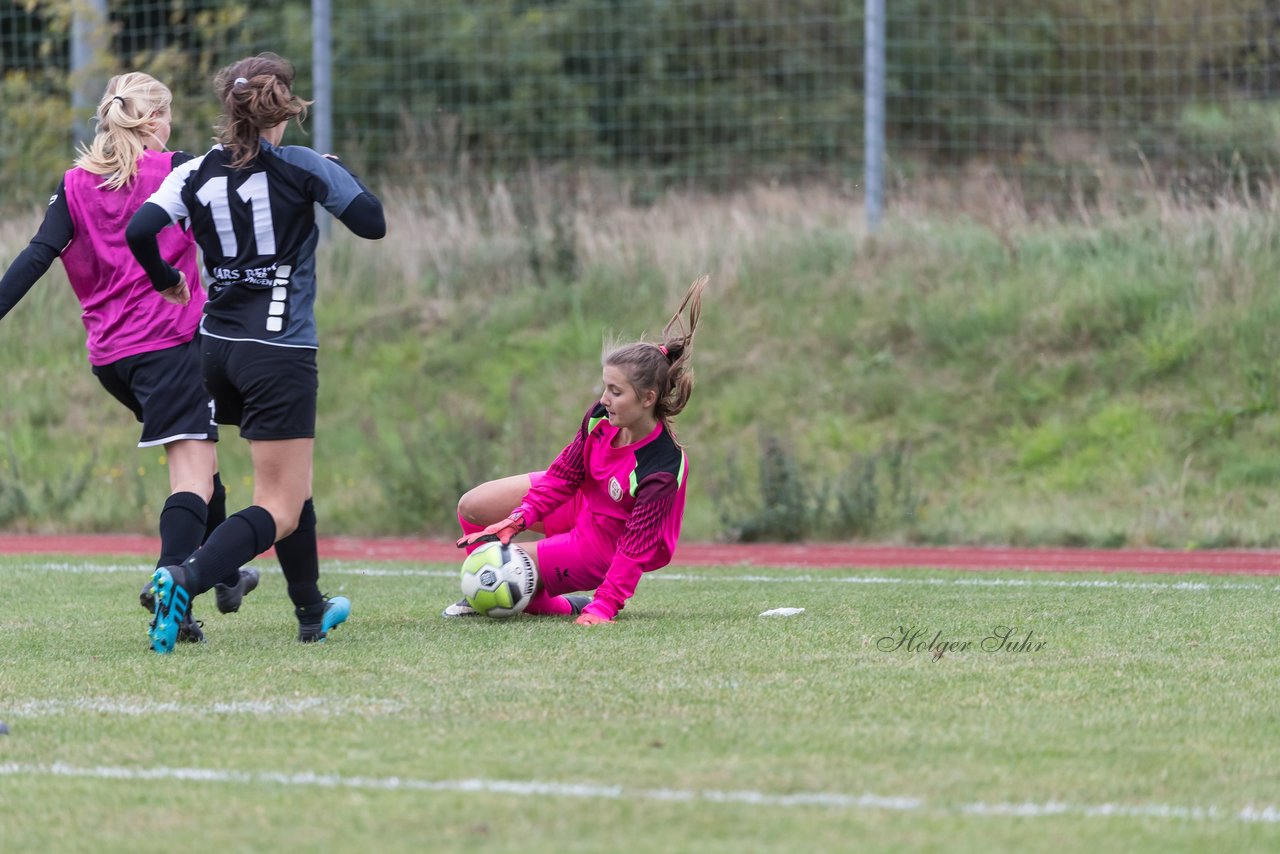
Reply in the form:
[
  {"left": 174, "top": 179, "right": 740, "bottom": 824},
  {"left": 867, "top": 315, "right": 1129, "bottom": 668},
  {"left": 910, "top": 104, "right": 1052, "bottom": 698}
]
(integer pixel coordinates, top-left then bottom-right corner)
[{"left": 127, "top": 54, "right": 387, "bottom": 653}]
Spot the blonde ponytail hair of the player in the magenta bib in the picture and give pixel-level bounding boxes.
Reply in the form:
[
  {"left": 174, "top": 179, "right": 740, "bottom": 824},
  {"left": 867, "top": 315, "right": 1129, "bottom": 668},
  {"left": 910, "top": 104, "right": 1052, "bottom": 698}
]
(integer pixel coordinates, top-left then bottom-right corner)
[{"left": 76, "top": 72, "right": 173, "bottom": 189}]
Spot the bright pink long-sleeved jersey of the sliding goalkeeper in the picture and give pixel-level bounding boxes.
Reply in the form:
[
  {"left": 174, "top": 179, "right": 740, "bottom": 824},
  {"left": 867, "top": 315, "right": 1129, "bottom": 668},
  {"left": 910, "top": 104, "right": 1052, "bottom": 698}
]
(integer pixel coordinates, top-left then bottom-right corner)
[{"left": 520, "top": 403, "right": 687, "bottom": 617}]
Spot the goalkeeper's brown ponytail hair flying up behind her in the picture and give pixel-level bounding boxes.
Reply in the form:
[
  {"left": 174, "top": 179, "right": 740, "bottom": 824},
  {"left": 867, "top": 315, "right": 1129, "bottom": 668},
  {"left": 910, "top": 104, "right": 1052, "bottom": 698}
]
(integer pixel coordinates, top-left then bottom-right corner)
[{"left": 604, "top": 275, "right": 710, "bottom": 445}]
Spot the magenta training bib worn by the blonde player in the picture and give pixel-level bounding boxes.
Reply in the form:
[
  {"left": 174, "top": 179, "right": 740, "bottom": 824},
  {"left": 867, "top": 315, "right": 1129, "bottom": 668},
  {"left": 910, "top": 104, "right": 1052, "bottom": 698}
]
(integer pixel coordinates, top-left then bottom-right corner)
[{"left": 61, "top": 151, "right": 205, "bottom": 365}]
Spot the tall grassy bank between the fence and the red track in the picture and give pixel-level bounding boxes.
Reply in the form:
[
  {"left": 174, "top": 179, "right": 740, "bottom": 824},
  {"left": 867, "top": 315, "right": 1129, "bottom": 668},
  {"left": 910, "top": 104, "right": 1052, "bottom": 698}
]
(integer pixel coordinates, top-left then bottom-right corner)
[{"left": 0, "top": 174, "right": 1280, "bottom": 547}]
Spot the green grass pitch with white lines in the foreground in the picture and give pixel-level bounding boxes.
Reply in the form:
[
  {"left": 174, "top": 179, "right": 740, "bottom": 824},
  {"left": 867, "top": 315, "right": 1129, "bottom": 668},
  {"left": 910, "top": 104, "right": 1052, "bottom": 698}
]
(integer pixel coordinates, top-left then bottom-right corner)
[{"left": 0, "top": 557, "right": 1280, "bottom": 851}]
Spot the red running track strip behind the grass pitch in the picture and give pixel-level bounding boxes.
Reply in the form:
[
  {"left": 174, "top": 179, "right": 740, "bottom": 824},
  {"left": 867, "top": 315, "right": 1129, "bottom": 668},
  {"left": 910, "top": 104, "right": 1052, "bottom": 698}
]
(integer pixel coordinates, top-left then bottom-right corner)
[{"left": 0, "top": 534, "right": 1280, "bottom": 575}]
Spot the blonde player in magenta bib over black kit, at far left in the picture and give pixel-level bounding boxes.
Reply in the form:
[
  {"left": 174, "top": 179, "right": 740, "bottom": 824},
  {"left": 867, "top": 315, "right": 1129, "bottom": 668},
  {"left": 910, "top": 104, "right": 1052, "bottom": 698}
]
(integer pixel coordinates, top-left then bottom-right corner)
[{"left": 0, "top": 72, "right": 257, "bottom": 641}]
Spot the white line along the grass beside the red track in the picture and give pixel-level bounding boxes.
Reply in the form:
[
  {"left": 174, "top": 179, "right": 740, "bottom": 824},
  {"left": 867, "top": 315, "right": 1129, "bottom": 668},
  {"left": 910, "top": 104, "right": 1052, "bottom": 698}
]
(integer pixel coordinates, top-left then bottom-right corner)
[{"left": 10, "top": 562, "right": 1280, "bottom": 593}]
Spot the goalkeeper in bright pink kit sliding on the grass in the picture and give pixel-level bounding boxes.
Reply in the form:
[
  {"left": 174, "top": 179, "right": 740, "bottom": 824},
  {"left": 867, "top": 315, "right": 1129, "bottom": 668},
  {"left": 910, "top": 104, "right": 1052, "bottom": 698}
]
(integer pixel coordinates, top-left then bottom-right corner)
[{"left": 444, "top": 277, "right": 707, "bottom": 625}]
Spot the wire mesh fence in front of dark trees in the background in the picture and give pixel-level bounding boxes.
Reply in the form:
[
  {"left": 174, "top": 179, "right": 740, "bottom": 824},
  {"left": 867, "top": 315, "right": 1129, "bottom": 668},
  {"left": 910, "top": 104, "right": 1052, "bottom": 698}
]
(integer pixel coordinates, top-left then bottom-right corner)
[{"left": 0, "top": 0, "right": 1280, "bottom": 212}]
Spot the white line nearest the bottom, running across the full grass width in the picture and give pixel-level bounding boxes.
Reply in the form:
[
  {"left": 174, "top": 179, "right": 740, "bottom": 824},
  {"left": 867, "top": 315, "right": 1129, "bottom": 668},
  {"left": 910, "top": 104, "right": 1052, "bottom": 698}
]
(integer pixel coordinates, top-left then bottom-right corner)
[{"left": 0, "top": 762, "right": 1280, "bottom": 825}]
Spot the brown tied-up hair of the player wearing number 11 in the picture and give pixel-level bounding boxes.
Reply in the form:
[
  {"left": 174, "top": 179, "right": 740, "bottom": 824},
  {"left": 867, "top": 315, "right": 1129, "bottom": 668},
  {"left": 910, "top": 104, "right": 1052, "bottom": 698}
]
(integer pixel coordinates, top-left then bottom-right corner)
[{"left": 214, "top": 52, "right": 311, "bottom": 169}]
